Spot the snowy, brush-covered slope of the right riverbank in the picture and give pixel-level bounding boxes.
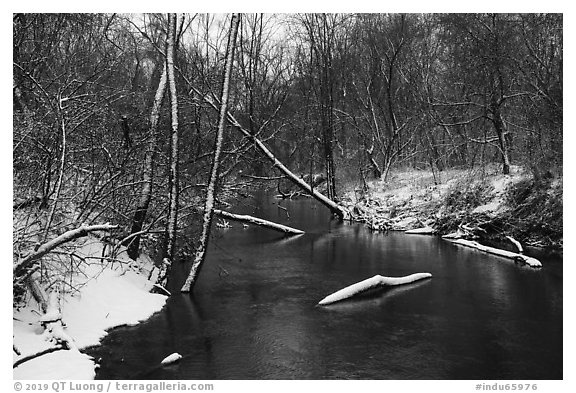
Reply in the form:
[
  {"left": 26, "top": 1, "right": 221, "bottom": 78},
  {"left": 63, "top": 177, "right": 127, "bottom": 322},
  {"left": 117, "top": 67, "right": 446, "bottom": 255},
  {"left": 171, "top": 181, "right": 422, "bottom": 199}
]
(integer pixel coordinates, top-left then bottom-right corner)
[{"left": 343, "top": 165, "right": 563, "bottom": 250}]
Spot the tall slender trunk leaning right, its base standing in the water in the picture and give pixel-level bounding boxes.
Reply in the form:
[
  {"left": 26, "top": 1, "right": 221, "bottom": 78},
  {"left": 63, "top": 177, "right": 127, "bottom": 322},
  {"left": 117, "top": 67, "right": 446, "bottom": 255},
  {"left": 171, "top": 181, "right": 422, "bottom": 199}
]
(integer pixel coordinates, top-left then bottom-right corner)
[{"left": 182, "top": 14, "right": 240, "bottom": 292}]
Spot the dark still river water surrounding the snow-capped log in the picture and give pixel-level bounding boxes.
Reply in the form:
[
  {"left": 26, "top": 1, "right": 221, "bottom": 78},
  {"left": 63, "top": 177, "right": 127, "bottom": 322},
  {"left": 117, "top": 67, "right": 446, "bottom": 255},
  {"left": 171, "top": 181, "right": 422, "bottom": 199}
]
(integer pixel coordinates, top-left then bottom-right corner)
[{"left": 89, "top": 191, "right": 563, "bottom": 380}]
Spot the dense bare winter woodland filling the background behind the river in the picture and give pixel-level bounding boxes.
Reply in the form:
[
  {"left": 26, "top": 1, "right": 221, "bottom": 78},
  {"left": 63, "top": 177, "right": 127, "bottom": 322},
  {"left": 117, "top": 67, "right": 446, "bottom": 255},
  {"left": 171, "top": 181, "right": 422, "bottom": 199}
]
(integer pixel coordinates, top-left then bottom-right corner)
[{"left": 13, "top": 14, "right": 563, "bottom": 288}]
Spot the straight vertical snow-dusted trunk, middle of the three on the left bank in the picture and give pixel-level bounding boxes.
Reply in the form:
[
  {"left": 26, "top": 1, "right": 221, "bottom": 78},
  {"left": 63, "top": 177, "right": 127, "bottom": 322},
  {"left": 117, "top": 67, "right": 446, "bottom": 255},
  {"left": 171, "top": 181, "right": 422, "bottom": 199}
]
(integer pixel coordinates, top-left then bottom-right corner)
[{"left": 164, "top": 14, "right": 179, "bottom": 259}]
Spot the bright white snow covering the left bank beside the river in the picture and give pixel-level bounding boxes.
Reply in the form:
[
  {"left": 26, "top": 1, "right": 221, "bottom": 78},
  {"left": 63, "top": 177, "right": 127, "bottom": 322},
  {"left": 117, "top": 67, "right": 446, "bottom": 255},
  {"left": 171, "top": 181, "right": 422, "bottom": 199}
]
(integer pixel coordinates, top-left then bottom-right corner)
[{"left": 13, "top": 237, "right": 166, "bottom": 380}]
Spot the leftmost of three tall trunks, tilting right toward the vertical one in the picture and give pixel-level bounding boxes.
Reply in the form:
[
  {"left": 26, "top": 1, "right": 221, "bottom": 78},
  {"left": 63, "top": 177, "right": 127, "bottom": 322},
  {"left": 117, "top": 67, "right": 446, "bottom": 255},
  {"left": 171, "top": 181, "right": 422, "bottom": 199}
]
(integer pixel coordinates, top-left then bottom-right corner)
[{"left": 128, "top": 62, "right": 167, "bottom": 260}]
